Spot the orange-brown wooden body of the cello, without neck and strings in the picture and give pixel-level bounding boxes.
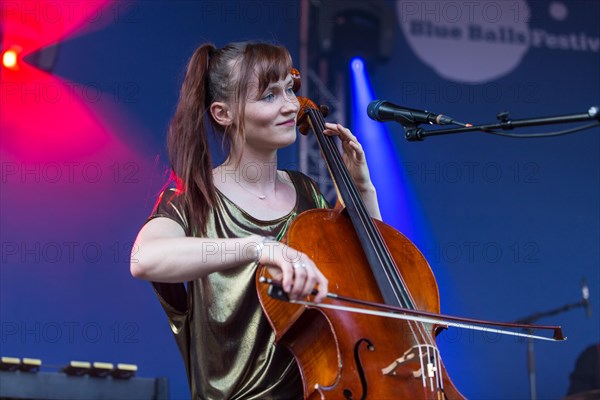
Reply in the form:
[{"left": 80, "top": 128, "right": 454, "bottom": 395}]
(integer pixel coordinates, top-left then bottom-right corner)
[{"left": 257, "top": 209, "right": 464, "bottom": 400}]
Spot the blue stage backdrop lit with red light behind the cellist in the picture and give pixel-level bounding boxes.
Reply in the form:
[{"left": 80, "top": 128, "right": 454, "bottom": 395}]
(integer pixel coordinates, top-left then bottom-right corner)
[{"left": 0, "top": 0, "right": 600, "bottom": 399}]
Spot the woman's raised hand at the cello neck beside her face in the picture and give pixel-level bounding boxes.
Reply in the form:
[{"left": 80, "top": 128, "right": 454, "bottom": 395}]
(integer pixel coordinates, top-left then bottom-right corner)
[{"left": 323, "top": 122, "right": 373, "bottom": 192}]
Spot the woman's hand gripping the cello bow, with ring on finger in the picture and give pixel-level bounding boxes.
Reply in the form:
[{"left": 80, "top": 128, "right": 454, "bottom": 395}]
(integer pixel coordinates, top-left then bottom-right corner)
[{"left": 257, "top": 240, "right": 329, "bottom": 303}]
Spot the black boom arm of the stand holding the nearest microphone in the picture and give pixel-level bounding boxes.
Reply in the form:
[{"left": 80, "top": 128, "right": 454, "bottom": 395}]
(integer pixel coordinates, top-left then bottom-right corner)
[{"left": 400, "top": 107, "right": 600, "bottom": 142}]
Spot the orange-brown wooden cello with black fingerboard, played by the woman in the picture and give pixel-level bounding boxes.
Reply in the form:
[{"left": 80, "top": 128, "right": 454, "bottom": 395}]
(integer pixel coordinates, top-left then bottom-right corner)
[{"left": 256, "top": 70, "right": 562, "bottom": 400}]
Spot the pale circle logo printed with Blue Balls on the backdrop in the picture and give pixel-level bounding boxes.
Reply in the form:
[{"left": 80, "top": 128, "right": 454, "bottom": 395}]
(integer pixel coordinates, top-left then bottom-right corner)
[{"left": 396, "top": 0, "right": 530, "bottom": 83}]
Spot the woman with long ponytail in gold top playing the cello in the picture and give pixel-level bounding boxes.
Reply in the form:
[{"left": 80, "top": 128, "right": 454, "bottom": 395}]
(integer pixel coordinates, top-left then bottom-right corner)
[{"left": 131, "top": 43, "right": 380, "bottom": 399}]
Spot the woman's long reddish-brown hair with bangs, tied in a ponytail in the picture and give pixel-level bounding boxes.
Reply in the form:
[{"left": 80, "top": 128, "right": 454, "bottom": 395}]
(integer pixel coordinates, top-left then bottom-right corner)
[{"left": 167, "top": 42, "right": 292, "bottom": 234}]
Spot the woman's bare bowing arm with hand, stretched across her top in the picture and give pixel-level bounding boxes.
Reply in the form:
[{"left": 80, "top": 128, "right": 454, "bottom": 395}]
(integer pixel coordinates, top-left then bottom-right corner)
[{"left": 130, "top": 217, "right": 328, "bottom": 301}]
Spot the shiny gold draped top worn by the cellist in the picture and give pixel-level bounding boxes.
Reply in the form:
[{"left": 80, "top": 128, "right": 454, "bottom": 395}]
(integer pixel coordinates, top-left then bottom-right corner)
[{"left": 150, "top": 171, "right": 327, "bottom": 399}]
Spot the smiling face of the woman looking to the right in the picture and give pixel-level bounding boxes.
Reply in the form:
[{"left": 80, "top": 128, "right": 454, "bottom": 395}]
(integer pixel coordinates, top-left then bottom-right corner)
[{"left": 244, "top": 75, "right": 299, "bottom": 150}]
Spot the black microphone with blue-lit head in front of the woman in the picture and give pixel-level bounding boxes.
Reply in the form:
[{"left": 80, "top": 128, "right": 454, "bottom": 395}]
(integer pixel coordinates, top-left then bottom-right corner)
[{"left": 367, "top": 100, "right": 470, "bottom": 127}]
